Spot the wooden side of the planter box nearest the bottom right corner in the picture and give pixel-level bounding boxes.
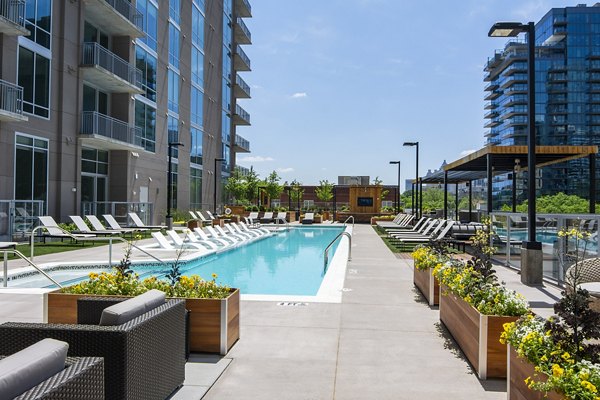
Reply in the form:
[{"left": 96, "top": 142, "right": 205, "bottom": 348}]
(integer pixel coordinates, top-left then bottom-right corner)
[{"left": 506, "top": 345, "right": 565, "bottom": 400}]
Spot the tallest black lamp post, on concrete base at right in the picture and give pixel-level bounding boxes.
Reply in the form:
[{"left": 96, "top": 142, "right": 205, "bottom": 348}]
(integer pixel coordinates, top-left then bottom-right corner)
[{"left": 488, "top": 22, "right": 543, "bottom": 285}]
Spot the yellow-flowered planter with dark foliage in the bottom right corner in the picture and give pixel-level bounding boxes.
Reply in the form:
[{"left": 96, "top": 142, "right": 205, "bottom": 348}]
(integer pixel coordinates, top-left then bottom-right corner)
[{"left": 502, "top": 229, "right": 600, "bottom": 400}]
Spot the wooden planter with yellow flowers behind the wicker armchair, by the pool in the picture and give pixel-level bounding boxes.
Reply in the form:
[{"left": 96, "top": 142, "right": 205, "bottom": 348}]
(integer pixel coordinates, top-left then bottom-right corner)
[{"left": 45, "top": 236, "right": 240, "bottom": 354}]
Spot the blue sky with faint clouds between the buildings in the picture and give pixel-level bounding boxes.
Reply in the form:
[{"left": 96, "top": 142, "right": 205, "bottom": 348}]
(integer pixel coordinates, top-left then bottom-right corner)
[{"left": 237, "top": 0, "right": 580, "bottom": 190}]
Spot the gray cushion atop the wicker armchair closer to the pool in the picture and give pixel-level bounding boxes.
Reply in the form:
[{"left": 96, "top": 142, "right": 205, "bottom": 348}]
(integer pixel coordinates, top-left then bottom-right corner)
[{"left": 100, "top": 289, "right": 166, "bottom": 325}]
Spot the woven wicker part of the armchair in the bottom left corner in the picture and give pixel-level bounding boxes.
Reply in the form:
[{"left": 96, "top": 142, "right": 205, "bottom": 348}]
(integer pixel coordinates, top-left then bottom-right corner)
[{"left": 0, "top": 356, "right": 104, "bottom": 400}]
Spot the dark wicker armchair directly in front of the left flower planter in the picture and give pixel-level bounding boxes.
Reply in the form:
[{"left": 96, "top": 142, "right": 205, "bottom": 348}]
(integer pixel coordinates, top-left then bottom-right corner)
[{"left": 0, "top": 298, "right": 185, "bottom": 400}]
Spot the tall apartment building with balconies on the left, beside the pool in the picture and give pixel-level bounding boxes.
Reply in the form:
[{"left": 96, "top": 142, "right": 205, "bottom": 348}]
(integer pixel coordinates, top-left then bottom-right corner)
[{"left": 0, "top": 0, "right": 251, "bottom": 228}]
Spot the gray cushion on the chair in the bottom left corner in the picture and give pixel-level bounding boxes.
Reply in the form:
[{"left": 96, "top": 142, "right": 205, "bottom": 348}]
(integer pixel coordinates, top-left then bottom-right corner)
[{"left": 0, "top": 339, "right": 69, "bottom": 399}]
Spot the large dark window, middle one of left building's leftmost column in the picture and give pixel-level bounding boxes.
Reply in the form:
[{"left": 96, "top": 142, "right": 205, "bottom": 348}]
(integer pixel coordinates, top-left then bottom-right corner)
[{"left": 18, "top": 46, "right": 50, "bottom": 118}]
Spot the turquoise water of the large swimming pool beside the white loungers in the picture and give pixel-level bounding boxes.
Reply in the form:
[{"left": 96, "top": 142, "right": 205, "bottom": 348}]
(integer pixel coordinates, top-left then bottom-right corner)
[{"left": 9, "top": 226, "right": 344, "bottom": 296}]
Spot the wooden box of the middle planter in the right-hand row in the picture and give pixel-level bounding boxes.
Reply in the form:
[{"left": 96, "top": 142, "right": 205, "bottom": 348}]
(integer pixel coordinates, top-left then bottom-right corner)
[{"left": 440, "top": 286, "right": 518, "bottom": 379}]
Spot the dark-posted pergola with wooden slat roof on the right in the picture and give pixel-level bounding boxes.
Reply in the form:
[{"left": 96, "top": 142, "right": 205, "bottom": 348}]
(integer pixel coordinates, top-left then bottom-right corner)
[{"left": 418, "top": 146, "right": 598, "bottom": 218}]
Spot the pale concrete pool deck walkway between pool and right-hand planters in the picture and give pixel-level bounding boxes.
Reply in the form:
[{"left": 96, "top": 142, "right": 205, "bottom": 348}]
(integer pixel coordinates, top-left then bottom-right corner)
[{"left": 2, "top": 225, "right": 560, "bottom": 400}]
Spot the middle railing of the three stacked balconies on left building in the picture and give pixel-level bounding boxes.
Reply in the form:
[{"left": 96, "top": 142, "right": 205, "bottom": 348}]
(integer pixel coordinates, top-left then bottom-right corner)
[{"left": 81, "top": 42, "right": 142, "bottom": 87}]
